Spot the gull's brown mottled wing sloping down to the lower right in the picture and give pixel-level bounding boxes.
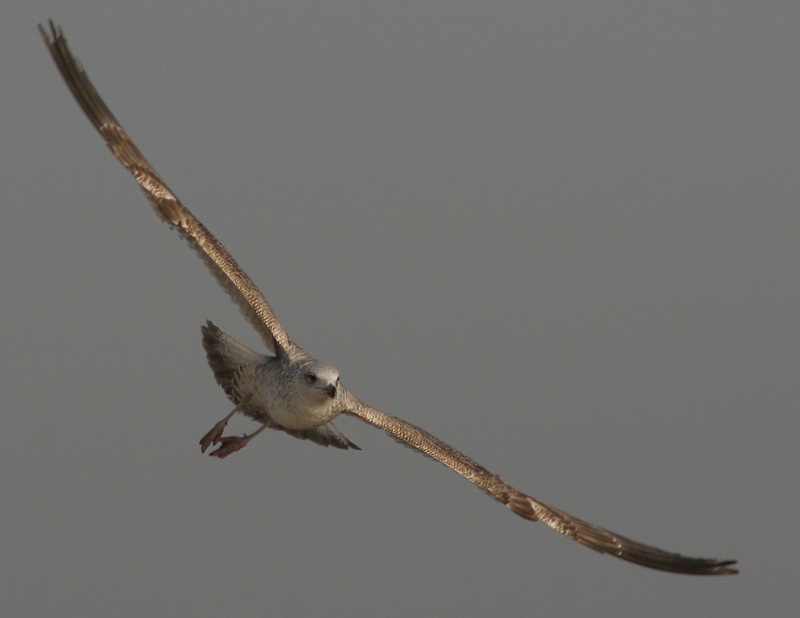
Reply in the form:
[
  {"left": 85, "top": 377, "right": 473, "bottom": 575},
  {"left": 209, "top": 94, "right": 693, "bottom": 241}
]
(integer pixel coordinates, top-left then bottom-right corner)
[{"left": 348, "top": 395, "right": 738, "bottom": 575}]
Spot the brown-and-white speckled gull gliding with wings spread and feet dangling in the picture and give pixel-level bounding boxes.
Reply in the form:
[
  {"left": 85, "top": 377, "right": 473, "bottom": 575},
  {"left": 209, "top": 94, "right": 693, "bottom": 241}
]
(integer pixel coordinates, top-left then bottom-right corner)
[{"left": 39, "top": 20, "right": 738, "bottom": 575}]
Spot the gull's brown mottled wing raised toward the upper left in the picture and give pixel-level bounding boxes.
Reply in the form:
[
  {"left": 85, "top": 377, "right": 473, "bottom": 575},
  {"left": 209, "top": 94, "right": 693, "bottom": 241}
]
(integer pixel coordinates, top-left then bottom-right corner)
[{"left": 39, "top": 20, "right": 304, "bottom": 358}]
